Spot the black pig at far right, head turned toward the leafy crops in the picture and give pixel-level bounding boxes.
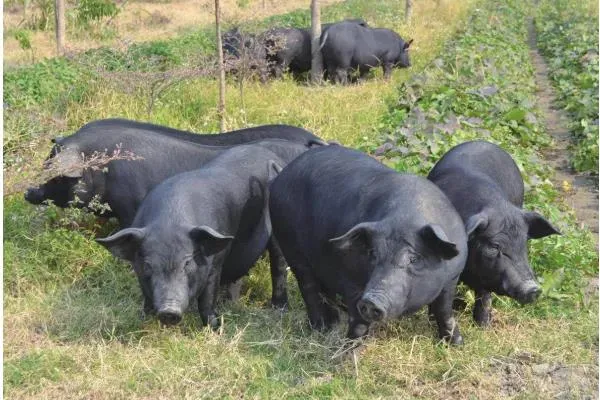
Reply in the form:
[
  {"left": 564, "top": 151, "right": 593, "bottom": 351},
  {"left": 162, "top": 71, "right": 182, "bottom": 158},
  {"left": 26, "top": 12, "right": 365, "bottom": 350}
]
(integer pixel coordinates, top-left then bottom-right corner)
[{"left": 428, "top": 141, "right": 559, "bottom": 326}]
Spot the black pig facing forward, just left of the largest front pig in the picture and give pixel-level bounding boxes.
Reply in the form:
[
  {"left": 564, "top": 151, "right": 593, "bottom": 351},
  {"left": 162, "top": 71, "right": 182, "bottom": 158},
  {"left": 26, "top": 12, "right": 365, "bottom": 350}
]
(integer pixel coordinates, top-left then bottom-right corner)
[{"left": 98, "top": 144, "right": 305, "bottom": 328}]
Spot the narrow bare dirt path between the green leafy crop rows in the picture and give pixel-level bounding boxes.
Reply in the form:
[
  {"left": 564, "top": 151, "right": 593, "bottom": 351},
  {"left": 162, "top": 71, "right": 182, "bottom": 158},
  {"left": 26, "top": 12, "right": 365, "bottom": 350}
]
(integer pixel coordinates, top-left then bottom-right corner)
[{"left": 529, "top": 20, "right": 598, "bottom": 247}]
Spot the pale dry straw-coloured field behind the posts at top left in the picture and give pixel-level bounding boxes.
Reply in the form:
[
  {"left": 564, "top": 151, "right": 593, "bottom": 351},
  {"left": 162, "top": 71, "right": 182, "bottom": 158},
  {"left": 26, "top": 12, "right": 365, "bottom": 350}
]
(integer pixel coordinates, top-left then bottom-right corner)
[{"left": 4, "top": 0, "right": 340, "bottom": 66}]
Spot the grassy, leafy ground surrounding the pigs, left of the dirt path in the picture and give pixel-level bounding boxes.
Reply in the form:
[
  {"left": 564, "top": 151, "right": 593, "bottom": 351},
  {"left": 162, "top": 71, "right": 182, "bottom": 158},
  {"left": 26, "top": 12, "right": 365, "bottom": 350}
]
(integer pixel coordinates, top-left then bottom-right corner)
[{"left": 4, "top": 0, "right": 598, "bottom": 399}]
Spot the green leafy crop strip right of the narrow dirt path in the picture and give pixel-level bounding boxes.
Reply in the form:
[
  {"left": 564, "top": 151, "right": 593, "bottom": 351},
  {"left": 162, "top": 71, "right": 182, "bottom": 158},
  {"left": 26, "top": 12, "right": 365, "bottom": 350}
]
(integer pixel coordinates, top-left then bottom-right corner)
[{"left": 535, "top": 0, "right": 599, "bottom": 174}]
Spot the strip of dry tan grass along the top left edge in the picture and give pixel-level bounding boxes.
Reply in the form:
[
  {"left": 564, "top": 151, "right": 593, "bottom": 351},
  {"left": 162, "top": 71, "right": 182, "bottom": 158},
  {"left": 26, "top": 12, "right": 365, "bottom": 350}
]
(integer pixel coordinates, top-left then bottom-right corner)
[{"left": 4, "top": 0, "right": 340, "bottom": 66}]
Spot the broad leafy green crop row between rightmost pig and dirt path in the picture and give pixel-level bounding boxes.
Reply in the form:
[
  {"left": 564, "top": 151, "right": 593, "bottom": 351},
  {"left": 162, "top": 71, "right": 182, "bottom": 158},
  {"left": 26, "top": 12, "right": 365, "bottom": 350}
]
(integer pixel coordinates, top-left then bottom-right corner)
[{"left": 363, "top": 0, "right": 598, "bottom": 313}]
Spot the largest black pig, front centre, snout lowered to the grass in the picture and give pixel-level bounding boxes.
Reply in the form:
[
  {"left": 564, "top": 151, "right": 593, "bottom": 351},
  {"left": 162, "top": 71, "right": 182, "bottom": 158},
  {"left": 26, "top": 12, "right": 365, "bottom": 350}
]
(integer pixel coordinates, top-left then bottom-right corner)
[{"left": 270, "top": 146, "right": 467, "bottom": 344}]
